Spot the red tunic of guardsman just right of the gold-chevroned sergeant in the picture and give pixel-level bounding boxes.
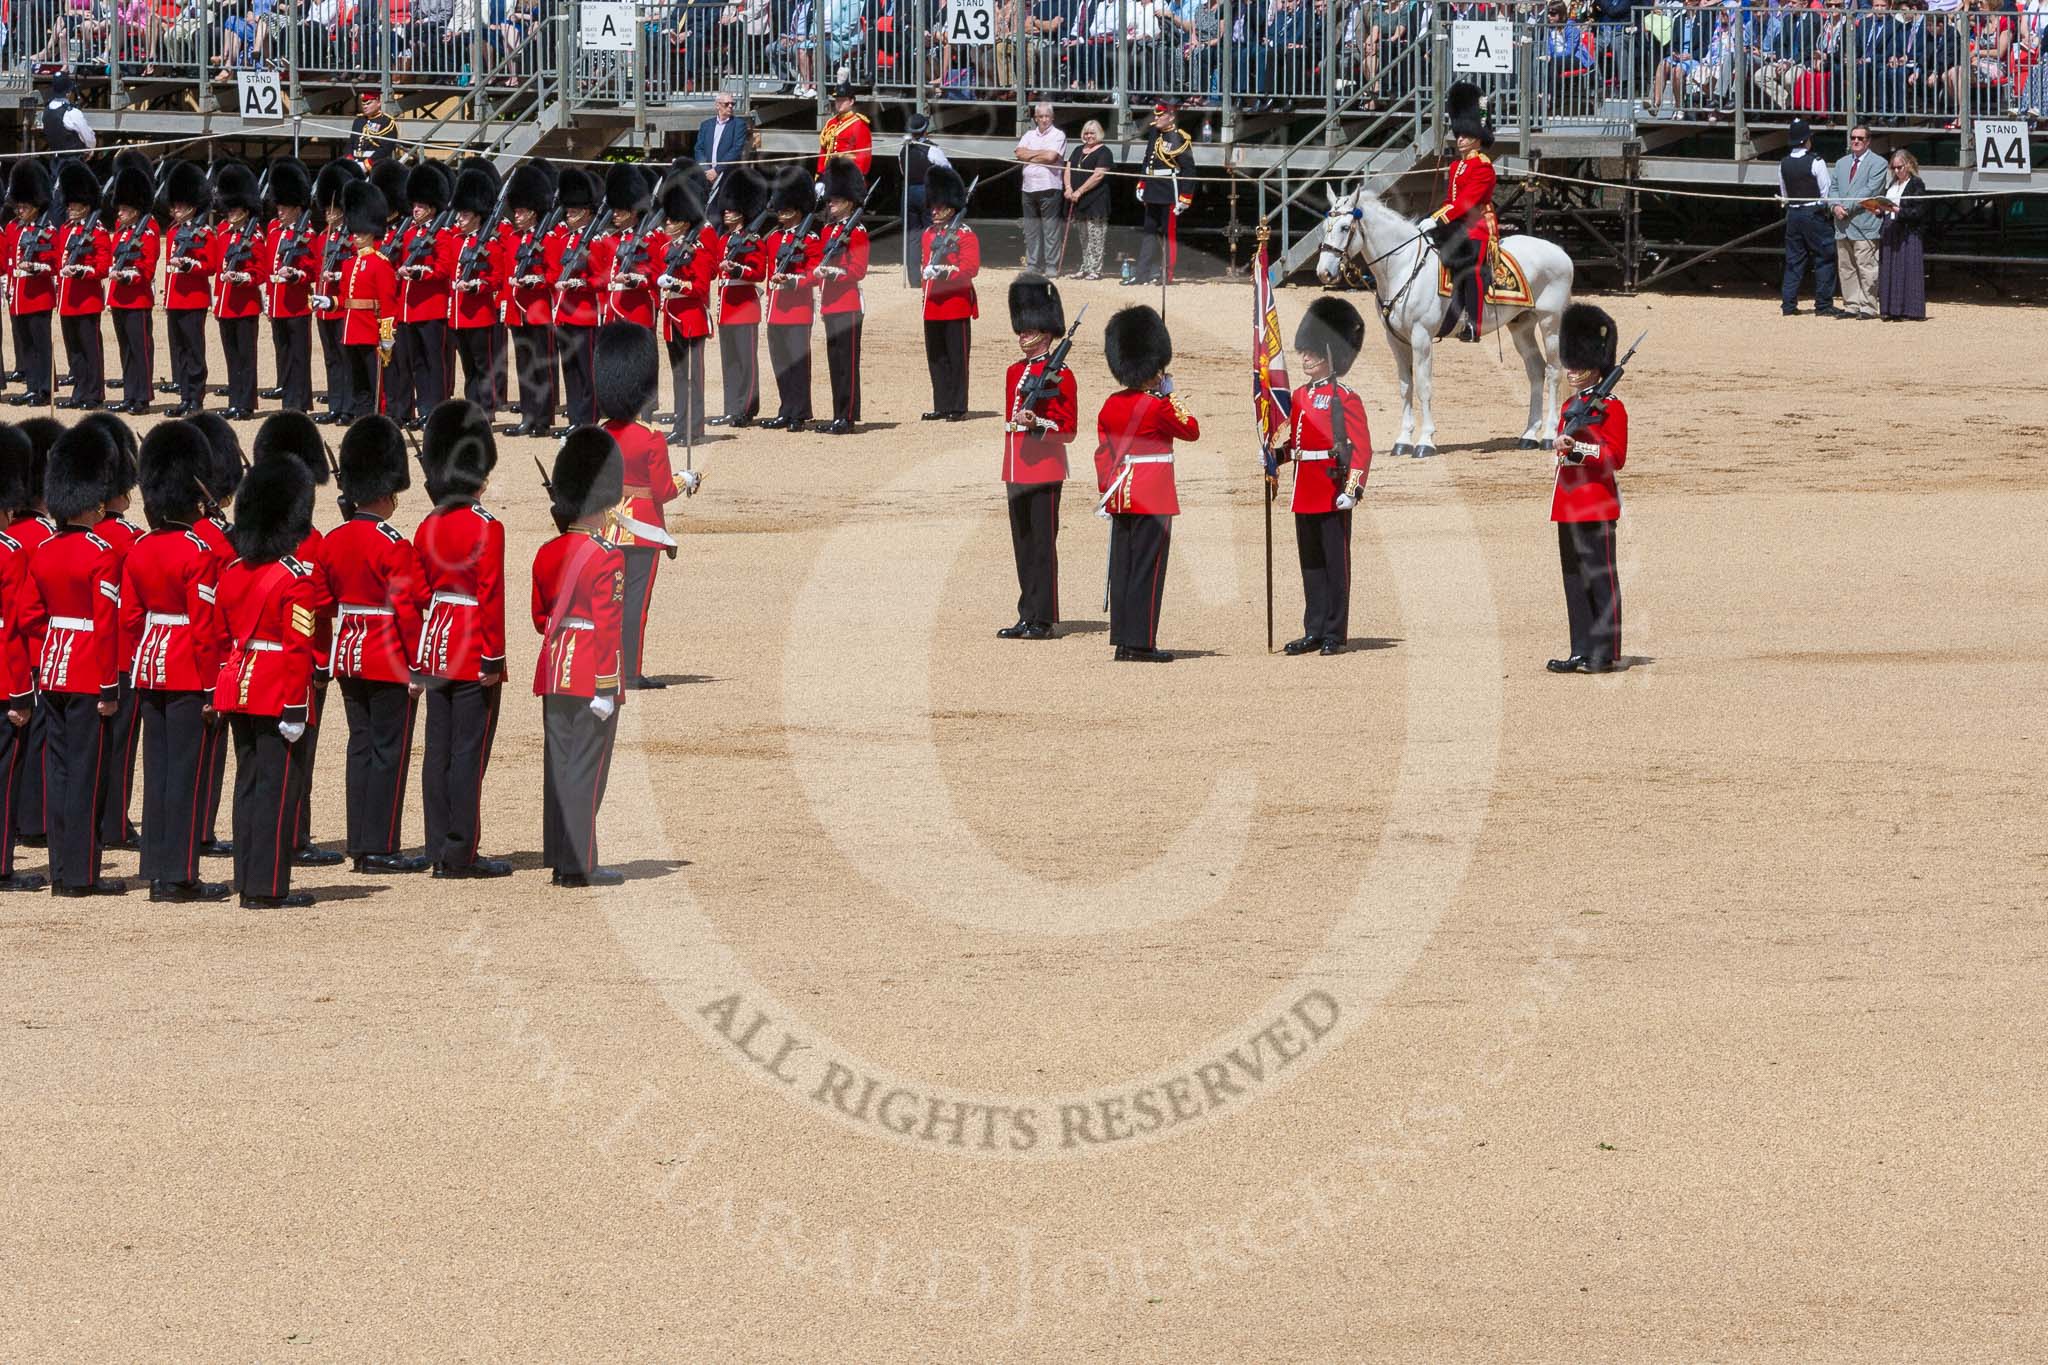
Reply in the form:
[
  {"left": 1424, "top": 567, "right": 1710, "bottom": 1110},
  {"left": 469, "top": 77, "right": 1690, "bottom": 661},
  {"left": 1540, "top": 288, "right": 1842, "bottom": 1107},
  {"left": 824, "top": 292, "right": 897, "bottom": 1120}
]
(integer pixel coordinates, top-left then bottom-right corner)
[{"left": 319, "top": 512, "right": 426, "bottom": 684}]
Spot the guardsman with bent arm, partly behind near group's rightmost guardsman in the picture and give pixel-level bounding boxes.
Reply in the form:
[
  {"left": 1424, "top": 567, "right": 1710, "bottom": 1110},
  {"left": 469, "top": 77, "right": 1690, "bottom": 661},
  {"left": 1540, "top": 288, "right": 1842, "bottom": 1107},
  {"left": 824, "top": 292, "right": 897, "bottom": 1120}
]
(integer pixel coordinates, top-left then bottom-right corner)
[{"left": 598, "top": 323, "right": 698, "bottom": 688}]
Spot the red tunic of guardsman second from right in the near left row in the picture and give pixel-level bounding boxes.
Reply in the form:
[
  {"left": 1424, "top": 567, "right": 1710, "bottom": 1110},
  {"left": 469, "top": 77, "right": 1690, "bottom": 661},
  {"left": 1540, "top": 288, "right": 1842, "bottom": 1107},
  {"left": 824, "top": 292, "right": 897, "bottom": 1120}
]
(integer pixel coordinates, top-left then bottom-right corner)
[{"left": 412, "top": 501, "right": 506, "bottom": 681}]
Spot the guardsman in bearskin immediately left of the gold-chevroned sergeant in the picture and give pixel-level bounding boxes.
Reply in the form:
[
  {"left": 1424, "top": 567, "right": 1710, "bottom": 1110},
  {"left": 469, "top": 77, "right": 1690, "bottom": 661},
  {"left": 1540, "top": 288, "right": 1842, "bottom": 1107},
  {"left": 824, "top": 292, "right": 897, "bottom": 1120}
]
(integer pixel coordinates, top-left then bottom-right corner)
[{"left": 121, "top": 422, "right": 227, "bottom": 900}]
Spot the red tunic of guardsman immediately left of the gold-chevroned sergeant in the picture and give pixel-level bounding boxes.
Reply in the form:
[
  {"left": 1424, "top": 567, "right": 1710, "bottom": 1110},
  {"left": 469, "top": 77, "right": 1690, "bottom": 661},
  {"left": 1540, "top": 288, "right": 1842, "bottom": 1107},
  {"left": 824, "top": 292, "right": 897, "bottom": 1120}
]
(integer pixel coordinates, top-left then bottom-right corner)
[{"left": 121, "top": 524, "right": 225, "bottom": 692}]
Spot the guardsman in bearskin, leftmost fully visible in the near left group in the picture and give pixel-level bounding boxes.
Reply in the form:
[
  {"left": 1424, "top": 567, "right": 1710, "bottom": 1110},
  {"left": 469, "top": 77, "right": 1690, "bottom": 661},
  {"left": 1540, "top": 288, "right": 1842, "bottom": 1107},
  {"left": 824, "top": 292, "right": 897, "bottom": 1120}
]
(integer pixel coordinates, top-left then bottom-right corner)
[{"left": 16, "top": 424, "right": 127, "bottom": 896}]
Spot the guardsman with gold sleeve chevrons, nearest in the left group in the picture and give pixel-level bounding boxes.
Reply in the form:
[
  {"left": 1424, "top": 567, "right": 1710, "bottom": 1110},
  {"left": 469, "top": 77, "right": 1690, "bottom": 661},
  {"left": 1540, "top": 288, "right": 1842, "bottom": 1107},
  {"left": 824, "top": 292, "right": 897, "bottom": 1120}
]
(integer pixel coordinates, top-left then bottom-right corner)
[{"left": 213, "top": 460, "right": 315, "bottom": 911}]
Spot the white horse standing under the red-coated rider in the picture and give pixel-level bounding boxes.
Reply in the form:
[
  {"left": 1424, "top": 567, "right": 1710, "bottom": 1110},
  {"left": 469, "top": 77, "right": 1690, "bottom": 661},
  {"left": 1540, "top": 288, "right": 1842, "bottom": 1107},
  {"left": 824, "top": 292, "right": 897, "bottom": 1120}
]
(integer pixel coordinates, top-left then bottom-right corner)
[{"left": 1315, "top": 186, "right": 1571, "bottom": 458}]
